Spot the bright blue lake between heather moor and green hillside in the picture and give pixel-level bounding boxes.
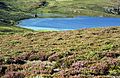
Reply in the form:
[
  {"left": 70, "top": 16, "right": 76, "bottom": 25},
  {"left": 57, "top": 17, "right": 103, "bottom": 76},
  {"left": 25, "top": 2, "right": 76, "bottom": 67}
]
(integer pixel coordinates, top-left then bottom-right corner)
[{"left": 18, "top": 16, "right": 120, "bottom": 31}]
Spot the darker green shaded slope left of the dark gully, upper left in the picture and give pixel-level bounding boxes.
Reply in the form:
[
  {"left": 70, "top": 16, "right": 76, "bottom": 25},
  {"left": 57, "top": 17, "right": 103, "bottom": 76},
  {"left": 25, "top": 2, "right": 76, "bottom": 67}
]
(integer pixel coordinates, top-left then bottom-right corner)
[{"left": 0, "top": 0, "right": 38, "bottom": 24}]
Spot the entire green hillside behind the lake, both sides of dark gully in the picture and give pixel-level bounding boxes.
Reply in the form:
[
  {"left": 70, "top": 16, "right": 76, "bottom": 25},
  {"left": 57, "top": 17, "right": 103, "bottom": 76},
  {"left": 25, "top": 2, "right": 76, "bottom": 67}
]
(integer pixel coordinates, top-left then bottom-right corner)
[{"left": 0, "top": 0, "right": 119, "bottom": 24}]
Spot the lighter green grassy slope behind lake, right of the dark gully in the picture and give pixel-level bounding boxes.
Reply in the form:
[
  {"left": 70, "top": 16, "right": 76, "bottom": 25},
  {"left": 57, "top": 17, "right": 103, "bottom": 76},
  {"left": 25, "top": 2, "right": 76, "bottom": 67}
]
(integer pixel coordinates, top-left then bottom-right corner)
[{"left": 37, "top": 0, "right": 120, "bottom": 16}]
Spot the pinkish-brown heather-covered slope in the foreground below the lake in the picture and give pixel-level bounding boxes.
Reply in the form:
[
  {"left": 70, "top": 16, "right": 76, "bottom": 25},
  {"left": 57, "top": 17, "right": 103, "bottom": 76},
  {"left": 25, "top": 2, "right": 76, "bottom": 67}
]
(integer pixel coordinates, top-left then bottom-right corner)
[{"left": 0, "top": 27, "right": 120, "bottom": 78}]
